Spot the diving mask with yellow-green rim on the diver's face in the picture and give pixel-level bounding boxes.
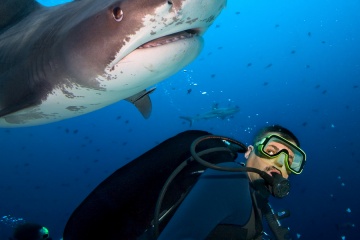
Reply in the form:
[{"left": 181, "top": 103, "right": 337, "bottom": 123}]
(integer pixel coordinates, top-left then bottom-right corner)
[{"left": 255, "top": 135, "right": 306, "bottom": 174}]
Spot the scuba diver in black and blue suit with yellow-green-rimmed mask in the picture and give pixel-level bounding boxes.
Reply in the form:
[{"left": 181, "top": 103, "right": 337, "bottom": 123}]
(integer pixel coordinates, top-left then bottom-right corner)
[{"left": 63, "top": 125, "right": 306, "bottom": 240}]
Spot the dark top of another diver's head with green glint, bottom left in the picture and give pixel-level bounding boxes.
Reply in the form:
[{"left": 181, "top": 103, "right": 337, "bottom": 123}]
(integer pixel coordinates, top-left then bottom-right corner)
[{"left": 9, "top": 223, "right": 51, "bottom": 240}]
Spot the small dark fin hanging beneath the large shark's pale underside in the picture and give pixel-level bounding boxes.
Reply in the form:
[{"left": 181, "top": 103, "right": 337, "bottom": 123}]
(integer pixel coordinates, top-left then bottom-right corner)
[{"left": 125, "top": 88, "right": 156, "bottom": 119}]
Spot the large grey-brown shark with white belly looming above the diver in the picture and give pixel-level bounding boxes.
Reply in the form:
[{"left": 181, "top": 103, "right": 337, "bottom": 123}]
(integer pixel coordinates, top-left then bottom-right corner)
[{"left": 0, "top": 0, "right": 226, "bottom": 127}]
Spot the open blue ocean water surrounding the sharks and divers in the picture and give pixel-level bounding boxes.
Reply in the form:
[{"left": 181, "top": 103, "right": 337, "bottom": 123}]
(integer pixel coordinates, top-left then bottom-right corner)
[{"left": 0, "top": 0, "right": 360, "bottom": 240}]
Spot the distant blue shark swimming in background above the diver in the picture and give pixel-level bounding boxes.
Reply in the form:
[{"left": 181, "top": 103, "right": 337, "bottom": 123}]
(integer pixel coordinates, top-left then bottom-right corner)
[{"left": 179, "top": 104, "right": 240, "bottom": 126}]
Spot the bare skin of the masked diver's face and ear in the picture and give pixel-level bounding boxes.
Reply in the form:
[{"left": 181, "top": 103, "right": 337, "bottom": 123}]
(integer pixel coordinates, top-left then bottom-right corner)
[{"left": 245, "top": 135, "right": 290, "bottom": 182}]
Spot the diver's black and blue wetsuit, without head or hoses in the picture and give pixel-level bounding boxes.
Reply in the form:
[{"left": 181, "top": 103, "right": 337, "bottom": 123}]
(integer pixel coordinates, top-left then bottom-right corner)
[{"left": 63, "top": 131, "right": 270, "bottom": 240}]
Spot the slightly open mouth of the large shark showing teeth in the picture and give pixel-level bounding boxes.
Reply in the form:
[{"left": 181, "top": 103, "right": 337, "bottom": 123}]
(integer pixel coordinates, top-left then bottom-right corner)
[{"left": 138, "top": 29, "right": 199, "bottom": 49}]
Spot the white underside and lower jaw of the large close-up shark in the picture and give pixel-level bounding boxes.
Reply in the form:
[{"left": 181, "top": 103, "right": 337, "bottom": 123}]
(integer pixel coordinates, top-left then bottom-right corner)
[{"left": 0, "top": 37, "right": 203, "bottom": 127}]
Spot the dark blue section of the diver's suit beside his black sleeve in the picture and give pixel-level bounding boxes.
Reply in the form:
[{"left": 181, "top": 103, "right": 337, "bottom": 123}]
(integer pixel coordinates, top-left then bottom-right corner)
[{"left": 158, "top": 162, "right": 267, "bottom": 240}]
